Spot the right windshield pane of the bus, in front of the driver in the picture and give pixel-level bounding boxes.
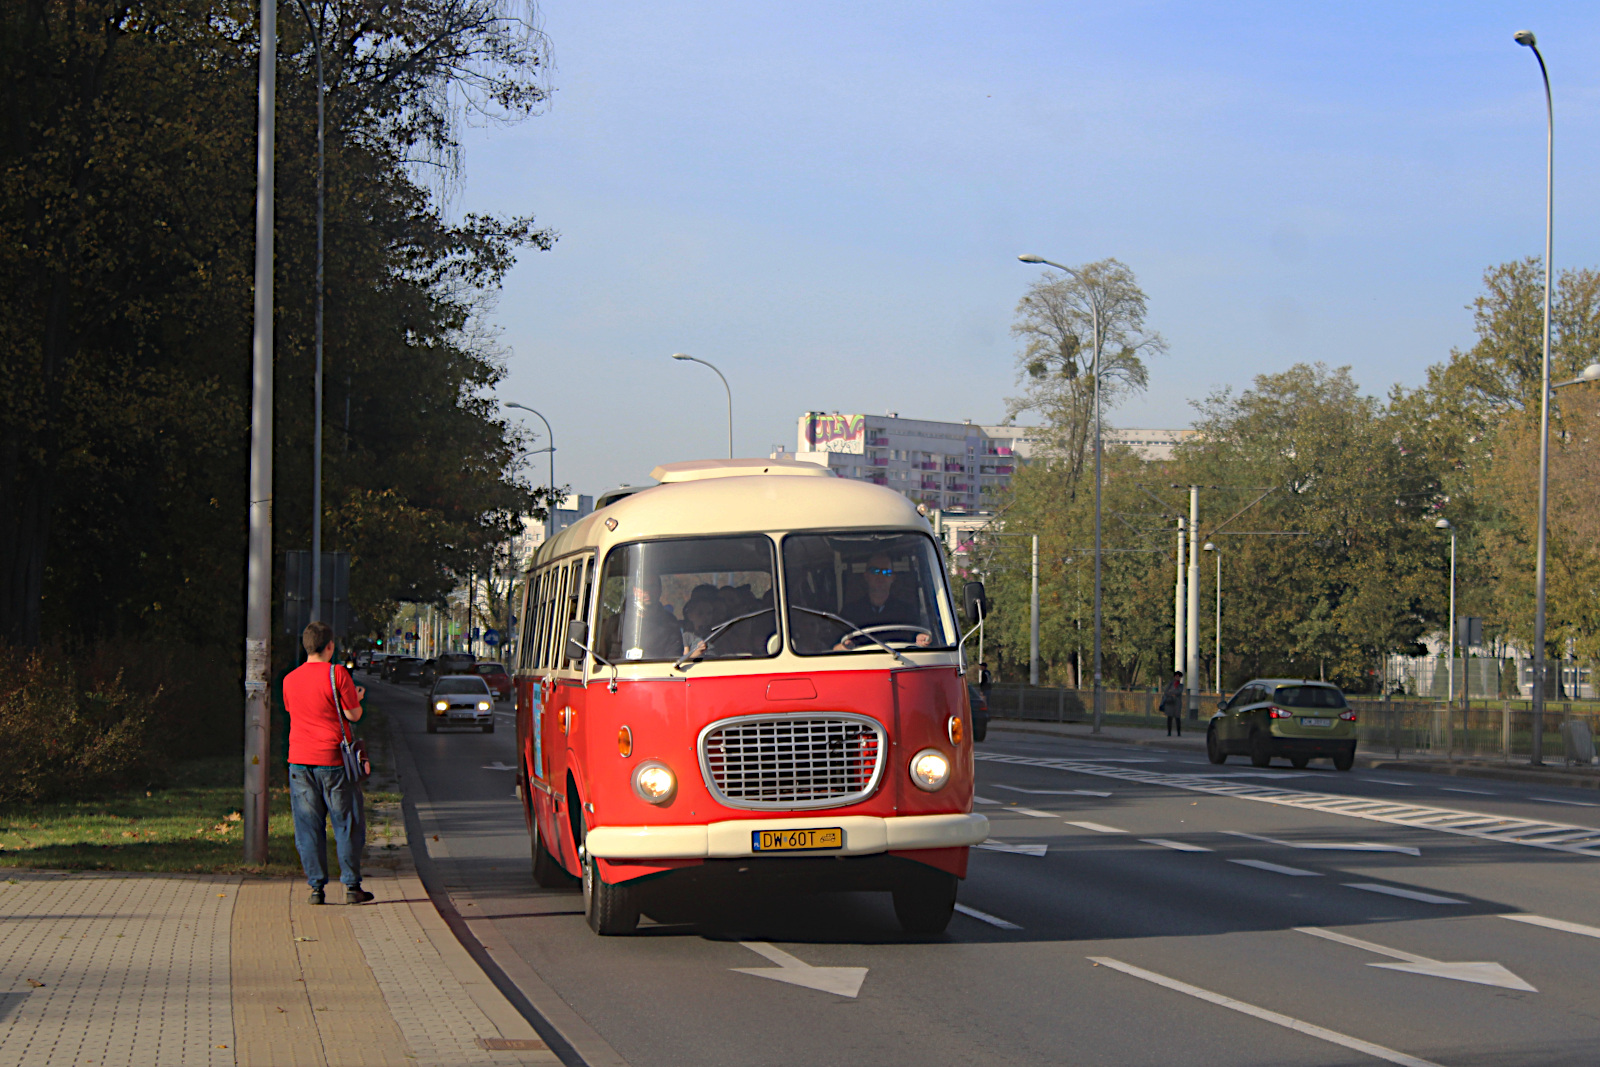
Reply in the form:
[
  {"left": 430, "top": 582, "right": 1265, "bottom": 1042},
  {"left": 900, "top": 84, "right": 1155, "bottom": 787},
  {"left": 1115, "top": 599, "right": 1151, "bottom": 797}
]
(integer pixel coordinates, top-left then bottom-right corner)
[{"left": 784, "top": 533, "right": 955, "bottom": 656}]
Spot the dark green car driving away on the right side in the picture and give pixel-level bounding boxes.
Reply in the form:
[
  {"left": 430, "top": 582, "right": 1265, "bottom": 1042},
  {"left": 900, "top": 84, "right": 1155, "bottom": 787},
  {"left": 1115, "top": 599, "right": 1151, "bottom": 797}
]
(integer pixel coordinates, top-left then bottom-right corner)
[{"left": 1205, "top": 678, "right": 1355, "bottom": 771}]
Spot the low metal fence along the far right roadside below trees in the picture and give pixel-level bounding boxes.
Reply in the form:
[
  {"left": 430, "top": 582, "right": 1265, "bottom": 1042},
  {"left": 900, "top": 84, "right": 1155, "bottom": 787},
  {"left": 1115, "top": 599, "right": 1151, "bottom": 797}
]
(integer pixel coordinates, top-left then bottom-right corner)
[{"left": 989, "top": 685, "right": 1600, "bottom": 763}]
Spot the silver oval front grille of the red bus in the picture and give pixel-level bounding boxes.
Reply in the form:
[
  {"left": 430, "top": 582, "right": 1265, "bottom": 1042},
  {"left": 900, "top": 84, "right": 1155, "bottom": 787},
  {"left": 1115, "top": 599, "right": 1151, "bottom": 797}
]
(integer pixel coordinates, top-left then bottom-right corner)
[{"left": 699, "top": 713, "right": 888, "bottom": 809}]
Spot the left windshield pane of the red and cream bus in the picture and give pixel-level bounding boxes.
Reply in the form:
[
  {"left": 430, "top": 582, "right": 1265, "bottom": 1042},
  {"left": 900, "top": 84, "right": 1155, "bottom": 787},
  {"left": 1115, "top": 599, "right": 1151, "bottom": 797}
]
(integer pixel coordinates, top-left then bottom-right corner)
[{"left": 595, "top": 536, "right": 779, "bottom": 662}]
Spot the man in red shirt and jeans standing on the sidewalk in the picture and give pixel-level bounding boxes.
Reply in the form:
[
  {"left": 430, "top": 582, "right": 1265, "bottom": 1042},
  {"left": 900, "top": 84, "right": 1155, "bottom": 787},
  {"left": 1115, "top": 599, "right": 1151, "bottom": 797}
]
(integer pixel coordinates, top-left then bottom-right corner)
[{"left": 283, "top": 622, "right": 373, "bottom": 904}]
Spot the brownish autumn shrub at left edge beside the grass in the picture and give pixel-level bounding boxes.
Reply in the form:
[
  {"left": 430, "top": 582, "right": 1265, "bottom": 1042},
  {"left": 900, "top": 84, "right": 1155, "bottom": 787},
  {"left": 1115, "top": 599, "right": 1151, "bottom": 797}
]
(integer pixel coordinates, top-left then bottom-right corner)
[{"left": 0, "top": 649, "right": 163, "bottom": 801}]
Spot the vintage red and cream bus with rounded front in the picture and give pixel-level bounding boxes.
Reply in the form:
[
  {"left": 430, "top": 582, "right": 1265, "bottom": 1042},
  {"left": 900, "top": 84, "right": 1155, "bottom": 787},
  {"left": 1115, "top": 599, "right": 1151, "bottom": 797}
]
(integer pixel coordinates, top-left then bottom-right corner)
[{"left": 515, "top": 459, "right": 989, "bottom": 934}]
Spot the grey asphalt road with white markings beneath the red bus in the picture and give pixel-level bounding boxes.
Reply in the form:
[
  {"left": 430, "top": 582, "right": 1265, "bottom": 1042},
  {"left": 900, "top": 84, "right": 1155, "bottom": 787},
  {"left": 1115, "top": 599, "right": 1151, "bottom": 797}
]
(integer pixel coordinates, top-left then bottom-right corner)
[{"left": 370, "top": 685, "right": 1600, "bottom": 1067}]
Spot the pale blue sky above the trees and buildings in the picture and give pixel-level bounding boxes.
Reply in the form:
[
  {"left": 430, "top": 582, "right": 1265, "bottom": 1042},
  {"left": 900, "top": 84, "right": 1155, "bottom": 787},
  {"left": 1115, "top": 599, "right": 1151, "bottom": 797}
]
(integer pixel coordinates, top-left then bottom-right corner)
[{"left": 453, "top": 0, "right": 1600, "bottom": 493}]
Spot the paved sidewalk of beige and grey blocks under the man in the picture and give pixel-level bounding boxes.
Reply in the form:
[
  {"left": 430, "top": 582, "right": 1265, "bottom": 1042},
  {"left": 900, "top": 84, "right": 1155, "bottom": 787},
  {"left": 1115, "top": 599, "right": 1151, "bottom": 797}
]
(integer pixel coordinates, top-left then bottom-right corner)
[{"left": 0, "top": 845, "right": 560, "bottom": 1067}]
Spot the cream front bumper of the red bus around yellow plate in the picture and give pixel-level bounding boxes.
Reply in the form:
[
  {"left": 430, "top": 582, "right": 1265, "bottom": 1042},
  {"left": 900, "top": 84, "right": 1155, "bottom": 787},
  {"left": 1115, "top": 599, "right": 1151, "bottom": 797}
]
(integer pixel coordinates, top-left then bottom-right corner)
[{"left": 584, "top": 813, "right": 989, "bottom": 859}]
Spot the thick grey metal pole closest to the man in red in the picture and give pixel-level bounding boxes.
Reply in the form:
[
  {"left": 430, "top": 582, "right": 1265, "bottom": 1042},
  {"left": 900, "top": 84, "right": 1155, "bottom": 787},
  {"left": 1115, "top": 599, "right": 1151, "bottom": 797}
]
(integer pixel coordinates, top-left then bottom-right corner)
[{"left": 243, "top": 0, "right": 278, "bottom": 864}]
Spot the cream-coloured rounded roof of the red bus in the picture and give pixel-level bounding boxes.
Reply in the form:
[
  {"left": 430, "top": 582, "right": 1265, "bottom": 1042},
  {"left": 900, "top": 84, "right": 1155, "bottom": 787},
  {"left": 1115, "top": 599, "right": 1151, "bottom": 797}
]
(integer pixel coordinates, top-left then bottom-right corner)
[{"left": 534, "top": 459, "right": 930, "bottom": 566}]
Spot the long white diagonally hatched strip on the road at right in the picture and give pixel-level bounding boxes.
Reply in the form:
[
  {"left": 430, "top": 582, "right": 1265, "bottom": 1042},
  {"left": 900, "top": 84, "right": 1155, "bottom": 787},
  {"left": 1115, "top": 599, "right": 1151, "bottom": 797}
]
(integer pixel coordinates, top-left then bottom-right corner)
[{"left": 976, "top": 752, "right": 1600, "bottom": 859}]
